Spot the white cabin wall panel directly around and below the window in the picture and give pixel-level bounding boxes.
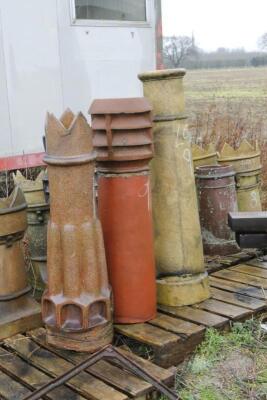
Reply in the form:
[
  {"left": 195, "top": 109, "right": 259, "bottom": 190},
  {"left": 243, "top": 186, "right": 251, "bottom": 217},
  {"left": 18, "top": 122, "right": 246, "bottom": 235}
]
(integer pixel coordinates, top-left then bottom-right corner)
[{"left": 57, "top": 0, "right": 156, "bottom": 114}]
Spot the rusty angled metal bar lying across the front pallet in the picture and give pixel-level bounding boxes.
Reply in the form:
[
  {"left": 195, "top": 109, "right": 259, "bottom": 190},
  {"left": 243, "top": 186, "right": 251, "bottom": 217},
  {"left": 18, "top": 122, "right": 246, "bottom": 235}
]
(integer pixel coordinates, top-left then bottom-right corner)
[{"left": 22, "top": 345, "right": 179, "bottom": 400}]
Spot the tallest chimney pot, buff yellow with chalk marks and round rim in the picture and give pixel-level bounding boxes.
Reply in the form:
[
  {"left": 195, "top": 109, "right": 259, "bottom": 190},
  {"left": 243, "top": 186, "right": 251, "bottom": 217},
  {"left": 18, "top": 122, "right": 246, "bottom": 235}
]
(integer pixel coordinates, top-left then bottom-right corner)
[{"left": 138, "top": 69, "right": 210, "bottom": 306}]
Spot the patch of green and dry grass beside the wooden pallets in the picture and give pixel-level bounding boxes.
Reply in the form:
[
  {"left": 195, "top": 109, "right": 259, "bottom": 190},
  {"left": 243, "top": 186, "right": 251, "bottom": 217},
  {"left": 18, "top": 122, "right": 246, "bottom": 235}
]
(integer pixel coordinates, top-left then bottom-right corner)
[{"left": 160, "top": 319, "right": 267, "bottom": 400}]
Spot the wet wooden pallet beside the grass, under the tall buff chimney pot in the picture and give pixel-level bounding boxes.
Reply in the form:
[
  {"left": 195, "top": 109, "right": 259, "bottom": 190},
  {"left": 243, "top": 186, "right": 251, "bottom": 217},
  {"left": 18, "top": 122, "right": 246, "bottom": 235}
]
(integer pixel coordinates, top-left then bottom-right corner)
[{"left": 115, "top": 259, "right": 267, "bottom": 368}]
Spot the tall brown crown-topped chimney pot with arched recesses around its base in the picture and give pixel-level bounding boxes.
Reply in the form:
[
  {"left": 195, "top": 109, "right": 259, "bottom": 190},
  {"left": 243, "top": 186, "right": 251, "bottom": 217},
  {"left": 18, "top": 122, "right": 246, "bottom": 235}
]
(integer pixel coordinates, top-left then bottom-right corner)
[{"left": 42, "top": 109, "right": 112, "bottom": 352}]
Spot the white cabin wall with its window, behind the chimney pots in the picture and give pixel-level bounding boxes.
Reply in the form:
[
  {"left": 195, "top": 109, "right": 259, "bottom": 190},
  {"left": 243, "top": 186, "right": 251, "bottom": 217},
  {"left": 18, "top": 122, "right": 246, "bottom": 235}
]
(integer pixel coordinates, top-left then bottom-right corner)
[{"left": 0, "top": 0, "right": 161, "bottom": 170}]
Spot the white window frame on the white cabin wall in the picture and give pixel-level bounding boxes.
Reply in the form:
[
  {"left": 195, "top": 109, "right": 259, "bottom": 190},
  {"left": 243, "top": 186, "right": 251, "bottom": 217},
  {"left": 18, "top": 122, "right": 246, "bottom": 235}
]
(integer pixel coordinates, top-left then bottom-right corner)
[{"left": 69, "top": 0, "right": 153, "bottom": 28}]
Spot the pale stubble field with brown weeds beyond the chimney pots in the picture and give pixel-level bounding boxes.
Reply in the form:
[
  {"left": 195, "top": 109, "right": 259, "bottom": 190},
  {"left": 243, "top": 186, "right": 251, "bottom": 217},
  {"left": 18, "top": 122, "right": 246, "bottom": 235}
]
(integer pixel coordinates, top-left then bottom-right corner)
[{"left": 184, "top": 67, "right": 267, "bottom": 148}]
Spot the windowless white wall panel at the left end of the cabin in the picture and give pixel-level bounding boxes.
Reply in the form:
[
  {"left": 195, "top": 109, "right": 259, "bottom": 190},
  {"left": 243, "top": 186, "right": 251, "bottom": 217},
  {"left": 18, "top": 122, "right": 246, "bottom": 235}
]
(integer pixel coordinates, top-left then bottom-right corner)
[{"left": 1, "top": 0, "right": 62, "bottom": 154}]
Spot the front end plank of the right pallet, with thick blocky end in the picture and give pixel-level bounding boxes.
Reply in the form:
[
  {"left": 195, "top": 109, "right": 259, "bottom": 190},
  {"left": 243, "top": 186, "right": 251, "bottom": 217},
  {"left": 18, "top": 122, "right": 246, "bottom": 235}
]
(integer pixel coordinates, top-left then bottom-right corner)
[{"left": 115, "top": 324, "right": 183, "bottom": 368}]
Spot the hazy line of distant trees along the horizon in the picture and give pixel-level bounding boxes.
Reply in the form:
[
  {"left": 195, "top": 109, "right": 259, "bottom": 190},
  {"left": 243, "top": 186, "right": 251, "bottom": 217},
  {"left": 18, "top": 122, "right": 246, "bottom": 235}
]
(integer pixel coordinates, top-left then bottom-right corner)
[{"left": 163, "top": 32, "right": 267, "bottom": 69}]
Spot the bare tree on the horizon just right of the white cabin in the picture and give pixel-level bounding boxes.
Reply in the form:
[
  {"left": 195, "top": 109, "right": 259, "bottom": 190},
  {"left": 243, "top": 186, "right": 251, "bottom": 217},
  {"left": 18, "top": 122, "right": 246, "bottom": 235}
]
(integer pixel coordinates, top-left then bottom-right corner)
[{"left": 163, "top": 36, "right": 197, "bottom": 67}]
